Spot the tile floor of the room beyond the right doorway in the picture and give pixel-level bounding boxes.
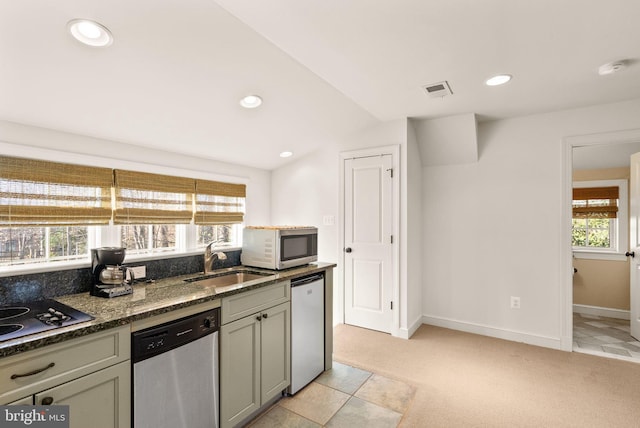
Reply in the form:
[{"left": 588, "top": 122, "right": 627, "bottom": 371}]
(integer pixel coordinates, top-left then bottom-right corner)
[{"left": 573, "top": 313, "right": 640, "bottom": 362}]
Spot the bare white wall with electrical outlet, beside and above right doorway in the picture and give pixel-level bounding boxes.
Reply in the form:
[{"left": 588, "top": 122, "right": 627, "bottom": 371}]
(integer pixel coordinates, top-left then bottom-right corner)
[{"left": 422, "top": 100, "right": 640, "bottom": 348}]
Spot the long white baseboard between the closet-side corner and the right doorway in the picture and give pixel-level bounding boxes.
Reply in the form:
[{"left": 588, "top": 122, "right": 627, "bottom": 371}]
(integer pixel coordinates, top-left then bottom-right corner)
[{"left": 422, "top": 315, "right": 565, "bottom": 350}]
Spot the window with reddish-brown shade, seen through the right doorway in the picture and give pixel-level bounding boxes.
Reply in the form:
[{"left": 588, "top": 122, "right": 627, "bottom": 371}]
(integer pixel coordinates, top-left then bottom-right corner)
[{"left": 572, "top": 180, "right": 628, "bottom": 258}]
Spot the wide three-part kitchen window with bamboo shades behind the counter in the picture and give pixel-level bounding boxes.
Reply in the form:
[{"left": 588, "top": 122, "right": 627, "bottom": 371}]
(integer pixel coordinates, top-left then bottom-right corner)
[{"left": 0, "top": 156, "right": 245, "bottom": 266}]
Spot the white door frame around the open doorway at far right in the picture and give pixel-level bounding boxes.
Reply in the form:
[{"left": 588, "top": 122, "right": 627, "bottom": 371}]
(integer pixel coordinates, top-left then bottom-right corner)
[{"left": 559, "top": 129, "right": 640, "bottom": 352}]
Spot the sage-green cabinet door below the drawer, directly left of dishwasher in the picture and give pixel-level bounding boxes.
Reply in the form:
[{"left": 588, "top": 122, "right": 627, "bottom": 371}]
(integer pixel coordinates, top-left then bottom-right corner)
[{"left": 35, "top": 361, "right": 131, "bottom": 428}]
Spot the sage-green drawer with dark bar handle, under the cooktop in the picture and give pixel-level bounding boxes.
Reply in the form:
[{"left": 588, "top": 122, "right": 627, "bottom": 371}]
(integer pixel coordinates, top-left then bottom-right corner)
[{"left": 0, "top": 325, "right": 131, "bottom": 403}]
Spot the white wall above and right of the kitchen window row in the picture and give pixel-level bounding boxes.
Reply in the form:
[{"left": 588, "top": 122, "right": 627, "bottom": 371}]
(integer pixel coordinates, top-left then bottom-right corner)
[{"left": 0, "top": 121, "right": 271, "bottom": 224}]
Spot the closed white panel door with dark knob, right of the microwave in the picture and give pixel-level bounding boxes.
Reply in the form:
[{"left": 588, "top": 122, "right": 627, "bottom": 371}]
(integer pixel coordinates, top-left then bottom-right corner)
[{"left": 344, "top": 155, "right": 393, "bottom": 333}]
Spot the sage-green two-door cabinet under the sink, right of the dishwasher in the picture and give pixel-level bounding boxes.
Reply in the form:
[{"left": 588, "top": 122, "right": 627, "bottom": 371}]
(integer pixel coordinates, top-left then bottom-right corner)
[{"left": 220, "top": 281, "right": 291, "bottom": 428}]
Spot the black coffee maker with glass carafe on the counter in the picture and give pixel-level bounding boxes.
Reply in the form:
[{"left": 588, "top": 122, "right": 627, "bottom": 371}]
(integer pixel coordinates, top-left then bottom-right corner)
[{"left": 91, "top": 247, "right": 134, "bottom": 297}]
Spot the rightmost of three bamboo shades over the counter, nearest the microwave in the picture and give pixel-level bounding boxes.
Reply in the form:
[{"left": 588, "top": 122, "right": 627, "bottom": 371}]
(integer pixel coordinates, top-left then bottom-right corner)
[{"left": 194, "top": 180, "right": 246, "bottom": 224}]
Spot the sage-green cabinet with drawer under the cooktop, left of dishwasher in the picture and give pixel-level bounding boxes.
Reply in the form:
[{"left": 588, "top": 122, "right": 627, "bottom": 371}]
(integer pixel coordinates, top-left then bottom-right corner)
[{"left": 0, "top": 325, "right": 131, "bottom": 428}]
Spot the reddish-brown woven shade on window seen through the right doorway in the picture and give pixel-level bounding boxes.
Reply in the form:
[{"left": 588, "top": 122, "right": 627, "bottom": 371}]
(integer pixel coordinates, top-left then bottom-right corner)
[{"left": 573, "top": 186, "right": 619, "bottom": 218}]
